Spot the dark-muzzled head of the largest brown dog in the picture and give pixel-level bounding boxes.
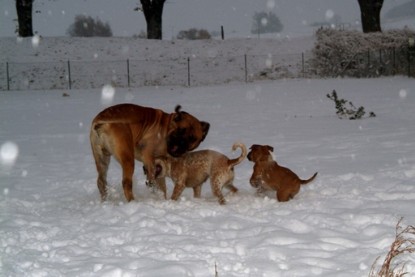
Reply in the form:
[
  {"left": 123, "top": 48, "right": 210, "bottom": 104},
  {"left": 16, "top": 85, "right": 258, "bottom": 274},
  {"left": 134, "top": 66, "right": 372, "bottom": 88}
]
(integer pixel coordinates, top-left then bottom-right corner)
[{"left": 167, "top": 106, "right": 210, "bottom": 157}]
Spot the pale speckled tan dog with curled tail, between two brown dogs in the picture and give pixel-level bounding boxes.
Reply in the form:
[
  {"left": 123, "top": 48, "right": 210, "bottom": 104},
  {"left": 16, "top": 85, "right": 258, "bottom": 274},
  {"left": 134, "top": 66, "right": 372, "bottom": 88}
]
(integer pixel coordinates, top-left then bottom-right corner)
[{"left": 156, "top": 143, "right": 247, "bottom": 205}]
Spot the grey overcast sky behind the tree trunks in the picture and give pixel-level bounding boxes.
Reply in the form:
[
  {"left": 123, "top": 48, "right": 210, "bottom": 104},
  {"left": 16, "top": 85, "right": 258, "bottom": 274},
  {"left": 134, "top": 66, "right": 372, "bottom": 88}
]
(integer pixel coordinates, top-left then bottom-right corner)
[{"left": 0, "top": 0, "right": 408, "bottom": 39}]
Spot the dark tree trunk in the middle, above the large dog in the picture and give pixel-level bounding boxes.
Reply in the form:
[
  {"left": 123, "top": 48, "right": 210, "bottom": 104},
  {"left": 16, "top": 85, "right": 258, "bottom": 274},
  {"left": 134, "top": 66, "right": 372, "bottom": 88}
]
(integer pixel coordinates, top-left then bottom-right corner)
[{"left": 140, "top": 0, "right": 166, "bottom": 39}]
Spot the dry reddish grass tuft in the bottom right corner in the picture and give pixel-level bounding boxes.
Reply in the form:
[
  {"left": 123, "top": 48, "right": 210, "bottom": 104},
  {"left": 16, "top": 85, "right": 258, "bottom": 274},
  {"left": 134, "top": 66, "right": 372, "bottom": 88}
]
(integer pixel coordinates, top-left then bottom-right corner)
[{"left": 369, "top": 218, "right": 415, "bottom": 277}]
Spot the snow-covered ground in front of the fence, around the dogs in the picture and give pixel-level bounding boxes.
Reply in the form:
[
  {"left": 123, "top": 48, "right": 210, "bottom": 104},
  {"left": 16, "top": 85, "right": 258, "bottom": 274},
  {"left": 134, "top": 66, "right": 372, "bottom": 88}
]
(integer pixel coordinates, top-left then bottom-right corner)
[{"left": 0, "top": 77, "right": 415, "bottom": 277}]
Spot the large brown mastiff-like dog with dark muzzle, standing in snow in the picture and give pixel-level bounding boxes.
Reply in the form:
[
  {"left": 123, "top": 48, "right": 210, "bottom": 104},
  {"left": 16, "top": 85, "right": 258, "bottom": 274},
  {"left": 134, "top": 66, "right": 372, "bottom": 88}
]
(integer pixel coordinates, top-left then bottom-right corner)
[{"left": 90, "top": 104, "right": 210, "bottom": 201}]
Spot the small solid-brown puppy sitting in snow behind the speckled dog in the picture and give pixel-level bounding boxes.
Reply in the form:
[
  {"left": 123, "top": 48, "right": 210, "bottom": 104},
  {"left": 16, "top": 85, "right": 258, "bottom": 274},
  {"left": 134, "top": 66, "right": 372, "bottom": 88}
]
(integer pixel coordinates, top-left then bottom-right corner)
[{"left": 248, "top": 144, "right": 317, "bottom": 202}]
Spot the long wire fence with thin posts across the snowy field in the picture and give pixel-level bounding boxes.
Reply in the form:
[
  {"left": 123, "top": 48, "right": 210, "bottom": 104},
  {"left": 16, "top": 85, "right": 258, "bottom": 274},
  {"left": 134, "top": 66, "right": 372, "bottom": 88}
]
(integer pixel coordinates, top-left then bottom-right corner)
[{"left": 0, "top": 48, "right": 415, "bottom": 90}]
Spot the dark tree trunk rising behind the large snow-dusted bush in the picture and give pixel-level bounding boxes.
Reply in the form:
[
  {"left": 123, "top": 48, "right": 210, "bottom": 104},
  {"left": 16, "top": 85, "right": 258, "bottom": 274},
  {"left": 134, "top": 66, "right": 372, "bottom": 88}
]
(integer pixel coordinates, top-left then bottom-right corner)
[{"left": 358, "top": 0, "right": 384, "bottom": 33}]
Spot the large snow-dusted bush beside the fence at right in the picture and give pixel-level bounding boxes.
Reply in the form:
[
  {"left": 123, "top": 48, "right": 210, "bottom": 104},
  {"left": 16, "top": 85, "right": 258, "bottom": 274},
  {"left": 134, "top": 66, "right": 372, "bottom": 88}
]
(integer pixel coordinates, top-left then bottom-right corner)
[{"left": 310, "top": 28, "right": 415, "bottom": 77}]
